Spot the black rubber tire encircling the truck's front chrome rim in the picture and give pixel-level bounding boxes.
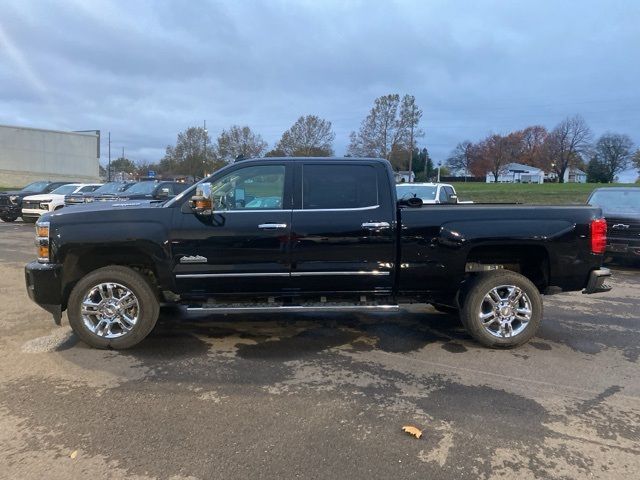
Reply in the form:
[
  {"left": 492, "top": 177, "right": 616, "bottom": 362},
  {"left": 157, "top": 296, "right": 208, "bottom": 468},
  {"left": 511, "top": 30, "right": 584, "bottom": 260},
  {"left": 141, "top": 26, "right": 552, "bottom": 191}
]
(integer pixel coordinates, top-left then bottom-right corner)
[{"left": 67, "top": 265, "right": 160, "bottom": 350}]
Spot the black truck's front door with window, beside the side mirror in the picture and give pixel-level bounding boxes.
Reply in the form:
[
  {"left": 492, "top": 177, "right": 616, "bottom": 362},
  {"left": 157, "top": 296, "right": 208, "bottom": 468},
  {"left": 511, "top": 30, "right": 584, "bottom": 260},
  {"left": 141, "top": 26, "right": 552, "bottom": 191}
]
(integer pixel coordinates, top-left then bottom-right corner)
[{"left": 171, "top": 161, "right": 291, "bottom": 296}]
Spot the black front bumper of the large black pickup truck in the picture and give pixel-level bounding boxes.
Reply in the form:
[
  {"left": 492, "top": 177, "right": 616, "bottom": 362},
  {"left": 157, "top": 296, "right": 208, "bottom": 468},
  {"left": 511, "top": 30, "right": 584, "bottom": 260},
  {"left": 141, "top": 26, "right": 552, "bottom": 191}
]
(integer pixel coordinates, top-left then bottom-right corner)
[{"left": 24, "top": 261, "right": 62, "bottom": 325}]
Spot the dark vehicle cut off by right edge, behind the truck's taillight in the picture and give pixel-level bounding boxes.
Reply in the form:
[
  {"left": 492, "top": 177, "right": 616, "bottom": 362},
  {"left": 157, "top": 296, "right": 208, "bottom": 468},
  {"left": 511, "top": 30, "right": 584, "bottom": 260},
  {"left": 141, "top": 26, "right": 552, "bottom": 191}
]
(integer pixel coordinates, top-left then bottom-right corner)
[{"left": 587, "top": 187, "right": 640, "bottom": 260}]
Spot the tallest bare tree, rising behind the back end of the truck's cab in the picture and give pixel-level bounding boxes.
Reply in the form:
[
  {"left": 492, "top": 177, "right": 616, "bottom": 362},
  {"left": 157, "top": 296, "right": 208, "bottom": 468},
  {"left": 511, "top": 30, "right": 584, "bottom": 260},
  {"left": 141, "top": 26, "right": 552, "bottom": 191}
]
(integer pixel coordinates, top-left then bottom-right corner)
[{"left": 347, "top": 94, "right": 423, "bottom": 160}]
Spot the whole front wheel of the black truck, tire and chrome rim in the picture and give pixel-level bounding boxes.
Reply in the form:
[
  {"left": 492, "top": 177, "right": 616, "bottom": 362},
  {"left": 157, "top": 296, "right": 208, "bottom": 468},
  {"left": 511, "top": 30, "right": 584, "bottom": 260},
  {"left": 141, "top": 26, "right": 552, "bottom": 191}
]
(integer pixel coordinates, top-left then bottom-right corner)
[{"left": 67, "top": 266, "right": 160, "bottom": 349}]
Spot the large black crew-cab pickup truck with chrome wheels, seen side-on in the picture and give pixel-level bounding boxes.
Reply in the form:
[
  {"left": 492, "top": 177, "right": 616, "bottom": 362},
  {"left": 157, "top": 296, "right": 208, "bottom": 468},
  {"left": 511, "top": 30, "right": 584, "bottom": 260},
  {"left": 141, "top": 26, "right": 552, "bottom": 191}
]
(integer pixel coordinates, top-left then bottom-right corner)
[{"left": 25, "top": 158, "right": 611, "bottom": 348}]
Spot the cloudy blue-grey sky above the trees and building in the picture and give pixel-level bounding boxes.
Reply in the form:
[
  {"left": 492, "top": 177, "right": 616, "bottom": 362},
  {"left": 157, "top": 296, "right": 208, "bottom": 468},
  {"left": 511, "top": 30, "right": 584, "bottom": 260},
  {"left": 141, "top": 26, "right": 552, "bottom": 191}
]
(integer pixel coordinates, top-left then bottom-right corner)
[{"left": 0, "top": 0, "right": 640, "bottom": 178}]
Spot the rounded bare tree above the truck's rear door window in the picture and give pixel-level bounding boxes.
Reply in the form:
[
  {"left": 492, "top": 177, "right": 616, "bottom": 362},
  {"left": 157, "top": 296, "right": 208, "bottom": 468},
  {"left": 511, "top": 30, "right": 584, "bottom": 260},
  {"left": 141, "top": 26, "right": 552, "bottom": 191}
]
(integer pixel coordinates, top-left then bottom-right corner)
[{"left": 275, "top": 115, "right": 336, "bottom": 157}]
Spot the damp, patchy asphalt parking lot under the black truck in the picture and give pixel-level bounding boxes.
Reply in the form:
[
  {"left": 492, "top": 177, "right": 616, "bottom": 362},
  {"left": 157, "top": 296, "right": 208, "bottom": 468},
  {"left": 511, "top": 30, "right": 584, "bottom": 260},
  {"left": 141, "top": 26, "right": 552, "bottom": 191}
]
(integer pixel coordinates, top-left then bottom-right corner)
[{"left": 0, "top": 222, "right": 640, "bottom": 479}]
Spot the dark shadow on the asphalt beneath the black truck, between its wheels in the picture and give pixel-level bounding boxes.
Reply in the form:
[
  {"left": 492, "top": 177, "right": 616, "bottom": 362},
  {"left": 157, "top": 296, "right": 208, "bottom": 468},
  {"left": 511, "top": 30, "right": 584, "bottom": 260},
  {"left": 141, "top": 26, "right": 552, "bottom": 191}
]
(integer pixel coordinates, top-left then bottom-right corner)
[{"left": 128, "top": 308, "right": 471, "bottom": 360}]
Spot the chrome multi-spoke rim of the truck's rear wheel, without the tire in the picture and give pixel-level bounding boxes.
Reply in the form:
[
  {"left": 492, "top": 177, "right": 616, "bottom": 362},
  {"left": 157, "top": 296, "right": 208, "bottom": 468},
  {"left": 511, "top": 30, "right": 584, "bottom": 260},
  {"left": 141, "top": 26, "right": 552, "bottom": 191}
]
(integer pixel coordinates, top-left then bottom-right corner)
[{"left": 478, "top": 285, "right": 532, "bottom": 338}]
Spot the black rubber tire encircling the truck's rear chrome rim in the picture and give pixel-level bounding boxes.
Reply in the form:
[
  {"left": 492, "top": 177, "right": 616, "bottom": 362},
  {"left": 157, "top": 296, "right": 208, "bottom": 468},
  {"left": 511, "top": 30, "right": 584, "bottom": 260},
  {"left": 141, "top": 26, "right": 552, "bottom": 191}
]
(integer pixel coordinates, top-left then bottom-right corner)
[{"left": 460, "top": 270, "right": 543, "bottom": 348}]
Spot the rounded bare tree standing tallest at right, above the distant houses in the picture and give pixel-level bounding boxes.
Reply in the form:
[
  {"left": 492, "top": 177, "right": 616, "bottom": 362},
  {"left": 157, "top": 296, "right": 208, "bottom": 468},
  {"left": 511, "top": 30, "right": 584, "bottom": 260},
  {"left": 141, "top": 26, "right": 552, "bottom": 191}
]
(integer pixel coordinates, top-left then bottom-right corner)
[{"left": 545, "top": 115, "right": 591, "bottom": 183}]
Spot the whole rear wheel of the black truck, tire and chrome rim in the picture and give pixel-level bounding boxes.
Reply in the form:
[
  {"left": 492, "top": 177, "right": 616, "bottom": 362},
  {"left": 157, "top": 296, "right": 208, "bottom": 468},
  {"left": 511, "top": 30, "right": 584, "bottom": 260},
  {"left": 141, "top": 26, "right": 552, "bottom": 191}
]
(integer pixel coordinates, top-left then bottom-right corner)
[{"left": 460, "top": 270, "right": 543, "bottom": 348}]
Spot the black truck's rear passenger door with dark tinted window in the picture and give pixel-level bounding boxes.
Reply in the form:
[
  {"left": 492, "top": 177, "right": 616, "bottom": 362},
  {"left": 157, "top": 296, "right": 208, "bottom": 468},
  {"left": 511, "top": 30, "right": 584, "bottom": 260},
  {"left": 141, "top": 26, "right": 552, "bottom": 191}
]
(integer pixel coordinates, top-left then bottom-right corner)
[{"left": 291, "top": 160, "right": 396, "bottom": 293}]
